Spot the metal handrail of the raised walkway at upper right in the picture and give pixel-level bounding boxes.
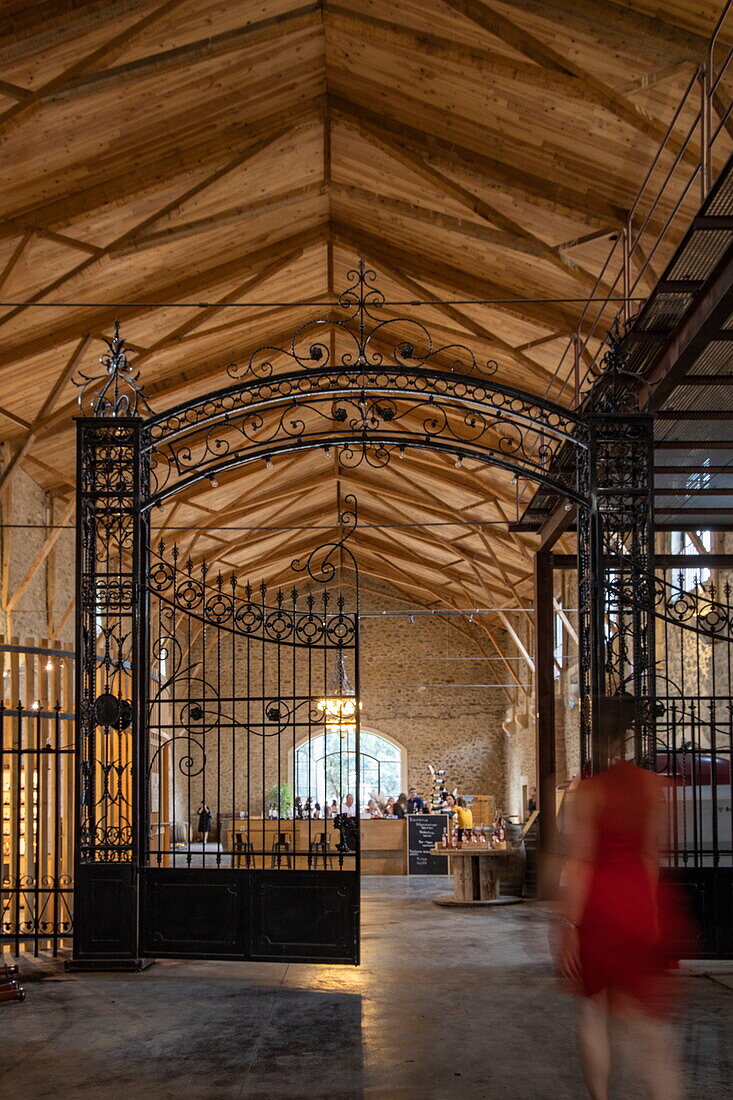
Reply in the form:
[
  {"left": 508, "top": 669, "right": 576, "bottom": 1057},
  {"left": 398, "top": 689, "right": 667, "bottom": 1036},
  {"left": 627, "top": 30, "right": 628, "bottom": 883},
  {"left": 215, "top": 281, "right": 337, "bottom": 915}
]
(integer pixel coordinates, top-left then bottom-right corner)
[{"left": 545, "top": 0, "right": 733, "bottom": 408}]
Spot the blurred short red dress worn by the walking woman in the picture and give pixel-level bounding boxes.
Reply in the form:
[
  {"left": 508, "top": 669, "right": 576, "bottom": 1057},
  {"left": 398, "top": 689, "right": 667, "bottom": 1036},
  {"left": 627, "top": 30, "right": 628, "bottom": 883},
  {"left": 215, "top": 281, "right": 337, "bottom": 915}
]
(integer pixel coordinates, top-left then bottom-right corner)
[{"left": 578, "top": 762, "right": 676, "bottom": 1012}]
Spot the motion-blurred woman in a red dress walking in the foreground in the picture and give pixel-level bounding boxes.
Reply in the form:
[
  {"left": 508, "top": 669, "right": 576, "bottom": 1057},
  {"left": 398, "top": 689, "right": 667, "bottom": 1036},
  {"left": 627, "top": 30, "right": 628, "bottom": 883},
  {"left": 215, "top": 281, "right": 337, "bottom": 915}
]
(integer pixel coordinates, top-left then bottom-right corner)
[{"left": 559, "top": 696, "right": 683, "bottom": 1100}]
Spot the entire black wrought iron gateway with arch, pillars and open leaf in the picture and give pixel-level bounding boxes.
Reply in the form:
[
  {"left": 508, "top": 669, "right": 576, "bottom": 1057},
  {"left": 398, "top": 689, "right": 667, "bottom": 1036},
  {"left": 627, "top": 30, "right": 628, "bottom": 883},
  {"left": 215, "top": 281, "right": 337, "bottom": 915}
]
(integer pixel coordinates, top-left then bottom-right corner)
[{"left": 65, "top": 263, "right": 654, "bottom": 965}]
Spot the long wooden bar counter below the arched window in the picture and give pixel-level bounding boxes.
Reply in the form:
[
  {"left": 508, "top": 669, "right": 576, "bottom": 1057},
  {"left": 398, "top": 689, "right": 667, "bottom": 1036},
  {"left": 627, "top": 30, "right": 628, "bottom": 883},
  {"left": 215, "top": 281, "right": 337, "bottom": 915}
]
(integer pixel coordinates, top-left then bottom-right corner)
[{"left": 221, "top": 817, "right": 407, "bottom": 875}]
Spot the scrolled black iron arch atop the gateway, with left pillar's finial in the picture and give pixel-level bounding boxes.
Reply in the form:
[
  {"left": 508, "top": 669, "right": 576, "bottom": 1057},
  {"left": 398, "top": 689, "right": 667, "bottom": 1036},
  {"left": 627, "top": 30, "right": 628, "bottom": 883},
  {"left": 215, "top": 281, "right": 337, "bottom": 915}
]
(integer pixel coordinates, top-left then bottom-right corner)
[{"left": 68, "top": 261, "right": 588, "bottom": 508}]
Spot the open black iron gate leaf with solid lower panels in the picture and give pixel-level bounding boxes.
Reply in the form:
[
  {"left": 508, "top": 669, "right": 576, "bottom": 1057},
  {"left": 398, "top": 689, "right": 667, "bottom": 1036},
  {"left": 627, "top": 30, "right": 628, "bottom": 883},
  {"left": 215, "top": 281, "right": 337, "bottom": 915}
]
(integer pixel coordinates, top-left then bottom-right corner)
[{"left": 140, "top": 516, "right": 359, "bottom": 964}]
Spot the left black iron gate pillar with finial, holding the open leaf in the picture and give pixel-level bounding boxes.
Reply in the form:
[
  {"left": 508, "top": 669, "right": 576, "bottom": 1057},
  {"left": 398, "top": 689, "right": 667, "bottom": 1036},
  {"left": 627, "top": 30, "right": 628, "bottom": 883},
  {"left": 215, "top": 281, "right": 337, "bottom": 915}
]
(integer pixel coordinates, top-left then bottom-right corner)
[{"left": 70, "top": 332, "right": 147, "bottom": 969}]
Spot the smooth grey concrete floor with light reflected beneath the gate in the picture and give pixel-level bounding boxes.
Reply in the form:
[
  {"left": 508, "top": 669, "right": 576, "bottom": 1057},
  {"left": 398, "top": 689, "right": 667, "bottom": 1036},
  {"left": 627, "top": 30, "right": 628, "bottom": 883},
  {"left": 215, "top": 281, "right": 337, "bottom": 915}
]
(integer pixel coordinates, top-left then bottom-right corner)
[{"left": 0, "top": 878, "right": 733, "bottom": 1100}]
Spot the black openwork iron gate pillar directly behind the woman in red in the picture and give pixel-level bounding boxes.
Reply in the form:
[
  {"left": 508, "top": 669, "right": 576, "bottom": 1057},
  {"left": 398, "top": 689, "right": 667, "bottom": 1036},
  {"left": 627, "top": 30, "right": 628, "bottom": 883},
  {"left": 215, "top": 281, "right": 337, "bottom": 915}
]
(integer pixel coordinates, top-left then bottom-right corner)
[{"left": 578, "top": 402, "right": 655, "bottom": 773}]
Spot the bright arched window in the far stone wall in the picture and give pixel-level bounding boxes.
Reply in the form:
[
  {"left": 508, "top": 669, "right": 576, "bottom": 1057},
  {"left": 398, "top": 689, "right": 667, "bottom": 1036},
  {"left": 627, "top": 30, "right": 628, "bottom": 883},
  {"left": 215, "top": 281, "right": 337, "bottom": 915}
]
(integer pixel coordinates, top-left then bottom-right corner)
[{"left": 294, "top": 729, "right": 404, "bottom": 806}]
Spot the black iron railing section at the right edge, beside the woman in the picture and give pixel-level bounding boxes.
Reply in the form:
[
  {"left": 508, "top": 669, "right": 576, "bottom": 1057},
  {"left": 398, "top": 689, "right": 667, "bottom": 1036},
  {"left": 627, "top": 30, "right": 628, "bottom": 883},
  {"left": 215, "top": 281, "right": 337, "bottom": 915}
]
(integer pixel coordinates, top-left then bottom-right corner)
[{"left": 654, "top": 556, "right": 733, "bottom": 957}]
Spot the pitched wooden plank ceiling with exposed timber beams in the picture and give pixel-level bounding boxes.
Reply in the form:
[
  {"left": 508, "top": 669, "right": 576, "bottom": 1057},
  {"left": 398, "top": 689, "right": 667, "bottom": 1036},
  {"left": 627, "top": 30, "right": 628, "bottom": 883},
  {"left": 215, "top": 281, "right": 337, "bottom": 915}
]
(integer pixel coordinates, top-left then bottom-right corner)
[{"left": 0, "top": 0, "right": 721, "bottom": 607}]
